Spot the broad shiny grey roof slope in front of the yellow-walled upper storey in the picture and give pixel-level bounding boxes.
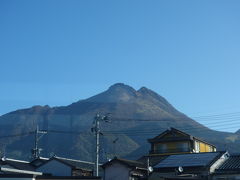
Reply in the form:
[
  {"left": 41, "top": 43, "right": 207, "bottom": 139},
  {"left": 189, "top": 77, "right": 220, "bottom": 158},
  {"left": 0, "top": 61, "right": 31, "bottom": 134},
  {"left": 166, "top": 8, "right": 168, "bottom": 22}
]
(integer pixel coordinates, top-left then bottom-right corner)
[{"left": 154, "top": 152, "right": 223, "bottom": 169}]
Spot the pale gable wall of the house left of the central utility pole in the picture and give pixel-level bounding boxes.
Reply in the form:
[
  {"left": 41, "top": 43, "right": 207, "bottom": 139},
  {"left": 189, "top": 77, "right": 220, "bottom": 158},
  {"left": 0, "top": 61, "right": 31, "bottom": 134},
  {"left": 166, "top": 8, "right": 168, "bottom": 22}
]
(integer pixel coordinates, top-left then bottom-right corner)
[{"left": 36, "top": 160, "right": 72, "bottom": 176}]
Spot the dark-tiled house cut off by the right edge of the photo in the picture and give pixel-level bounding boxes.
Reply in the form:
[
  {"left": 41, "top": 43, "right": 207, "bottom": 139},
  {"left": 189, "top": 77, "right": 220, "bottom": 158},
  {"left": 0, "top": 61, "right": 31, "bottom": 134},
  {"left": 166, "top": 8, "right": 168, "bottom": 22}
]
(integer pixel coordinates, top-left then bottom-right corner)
[{"left": 212, "top": 154, "right": 240, "bottom": 180}]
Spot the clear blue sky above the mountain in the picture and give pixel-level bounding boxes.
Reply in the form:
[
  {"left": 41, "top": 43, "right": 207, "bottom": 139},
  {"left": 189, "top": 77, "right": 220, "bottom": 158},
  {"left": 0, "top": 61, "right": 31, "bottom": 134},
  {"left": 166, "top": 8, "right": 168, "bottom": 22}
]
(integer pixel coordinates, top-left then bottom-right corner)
[{"left": 0, "top": 0, "right": 240, "bottom": 131}]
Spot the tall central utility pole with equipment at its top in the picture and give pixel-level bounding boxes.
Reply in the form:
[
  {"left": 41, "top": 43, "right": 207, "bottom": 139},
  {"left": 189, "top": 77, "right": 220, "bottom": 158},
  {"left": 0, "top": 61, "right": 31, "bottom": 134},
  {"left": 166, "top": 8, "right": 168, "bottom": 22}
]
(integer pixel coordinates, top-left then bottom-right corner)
[{"left": 92, "top": 113, "right": 109, "bottom": 176}]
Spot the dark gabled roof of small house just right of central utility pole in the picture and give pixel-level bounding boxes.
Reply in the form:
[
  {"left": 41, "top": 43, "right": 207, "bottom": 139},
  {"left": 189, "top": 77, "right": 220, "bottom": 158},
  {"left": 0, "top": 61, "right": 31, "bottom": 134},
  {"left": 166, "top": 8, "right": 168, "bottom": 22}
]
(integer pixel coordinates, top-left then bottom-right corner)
[{"left": 102, "top": 157, "right": 147, "bottom": 168}]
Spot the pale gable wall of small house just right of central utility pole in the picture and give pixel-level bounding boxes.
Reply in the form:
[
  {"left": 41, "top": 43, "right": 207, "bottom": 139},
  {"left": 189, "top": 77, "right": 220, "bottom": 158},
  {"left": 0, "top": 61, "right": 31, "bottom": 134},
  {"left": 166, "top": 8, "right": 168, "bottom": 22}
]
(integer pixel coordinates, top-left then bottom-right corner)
[{"left": 104, "top": 162, "right": 130, "bottom": 180}]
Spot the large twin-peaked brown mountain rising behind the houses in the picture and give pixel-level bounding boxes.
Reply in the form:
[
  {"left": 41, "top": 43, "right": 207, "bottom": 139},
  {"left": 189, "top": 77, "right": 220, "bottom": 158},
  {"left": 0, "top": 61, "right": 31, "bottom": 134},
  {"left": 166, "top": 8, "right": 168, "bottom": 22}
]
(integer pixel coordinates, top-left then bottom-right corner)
[{"left": 0, "top": 83, "right": 240, "bottom": 160}]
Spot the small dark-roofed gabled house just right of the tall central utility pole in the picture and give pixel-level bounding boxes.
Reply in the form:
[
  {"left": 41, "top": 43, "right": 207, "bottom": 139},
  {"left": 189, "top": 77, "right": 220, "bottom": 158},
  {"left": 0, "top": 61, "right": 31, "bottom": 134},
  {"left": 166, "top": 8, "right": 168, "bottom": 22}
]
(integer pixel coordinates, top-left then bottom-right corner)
[{"left": 102, "top": 157, "right": 147, "bottom": 180}]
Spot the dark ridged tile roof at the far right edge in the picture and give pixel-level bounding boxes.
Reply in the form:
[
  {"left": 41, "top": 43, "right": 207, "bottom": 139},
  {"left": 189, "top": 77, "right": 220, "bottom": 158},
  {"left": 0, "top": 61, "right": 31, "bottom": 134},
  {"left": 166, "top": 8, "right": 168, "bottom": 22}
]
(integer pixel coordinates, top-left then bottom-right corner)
[{"left": 216, "top": 154, "right": 240, "bottom": 173}]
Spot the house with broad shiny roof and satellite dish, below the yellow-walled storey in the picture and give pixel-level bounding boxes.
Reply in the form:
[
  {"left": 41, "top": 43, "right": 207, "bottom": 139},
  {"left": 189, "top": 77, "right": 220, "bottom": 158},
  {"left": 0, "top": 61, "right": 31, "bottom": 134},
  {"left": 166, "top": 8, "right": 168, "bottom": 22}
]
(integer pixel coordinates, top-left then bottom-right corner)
[{"left": 149, "top": 152, "right": 229, "bottom": 180}]
